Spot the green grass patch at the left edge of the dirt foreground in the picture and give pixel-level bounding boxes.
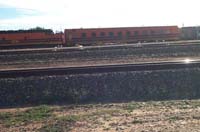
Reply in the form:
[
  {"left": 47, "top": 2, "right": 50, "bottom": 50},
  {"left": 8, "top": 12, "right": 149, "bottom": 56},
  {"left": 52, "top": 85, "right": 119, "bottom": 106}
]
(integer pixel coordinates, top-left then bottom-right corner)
[{"left": 0, "top": 105, "right": 52, "bottom": 127}]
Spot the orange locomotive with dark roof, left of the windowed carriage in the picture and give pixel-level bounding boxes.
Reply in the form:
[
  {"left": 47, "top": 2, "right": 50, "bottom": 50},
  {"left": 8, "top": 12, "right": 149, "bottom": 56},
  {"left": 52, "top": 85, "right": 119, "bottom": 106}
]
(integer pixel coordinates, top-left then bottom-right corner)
[{"left": 0, "top": 29, "right": 63, "bottom": 46}]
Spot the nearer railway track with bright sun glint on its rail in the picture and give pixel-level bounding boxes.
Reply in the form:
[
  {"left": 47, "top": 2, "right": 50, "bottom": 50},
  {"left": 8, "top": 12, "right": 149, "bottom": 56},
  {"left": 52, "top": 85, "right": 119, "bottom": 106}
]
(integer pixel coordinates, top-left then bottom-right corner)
[{"left": 0, "top": 59, "right": 200, "bottom": 78}]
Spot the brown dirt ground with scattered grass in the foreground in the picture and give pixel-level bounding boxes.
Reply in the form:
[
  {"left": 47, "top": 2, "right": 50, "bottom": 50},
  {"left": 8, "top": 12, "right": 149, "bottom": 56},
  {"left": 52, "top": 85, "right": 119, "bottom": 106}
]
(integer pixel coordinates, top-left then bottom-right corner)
[{"left": 0, "top": 100, "right": 200, "bottom": 132}]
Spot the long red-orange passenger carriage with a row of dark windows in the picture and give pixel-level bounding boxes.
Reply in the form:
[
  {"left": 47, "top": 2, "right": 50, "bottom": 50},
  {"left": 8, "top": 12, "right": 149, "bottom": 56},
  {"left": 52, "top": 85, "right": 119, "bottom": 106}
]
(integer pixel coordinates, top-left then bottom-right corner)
[{"left": 64, "top": 26, "right": 180, "bottom": 45}]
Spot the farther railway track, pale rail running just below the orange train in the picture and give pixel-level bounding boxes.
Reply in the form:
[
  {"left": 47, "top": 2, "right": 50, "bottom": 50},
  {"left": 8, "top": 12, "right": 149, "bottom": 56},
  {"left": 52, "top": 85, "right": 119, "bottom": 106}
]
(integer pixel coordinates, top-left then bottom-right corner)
[{"left": 0, "top": 40, "right": 200, "bottom": 55}]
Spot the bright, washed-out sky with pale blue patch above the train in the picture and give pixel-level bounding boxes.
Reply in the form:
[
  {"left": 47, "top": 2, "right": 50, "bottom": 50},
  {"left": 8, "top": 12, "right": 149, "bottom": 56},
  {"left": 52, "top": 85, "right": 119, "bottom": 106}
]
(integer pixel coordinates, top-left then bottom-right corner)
[{"left": 0, "top": 0, "right": 200, "bottom": 31}]
